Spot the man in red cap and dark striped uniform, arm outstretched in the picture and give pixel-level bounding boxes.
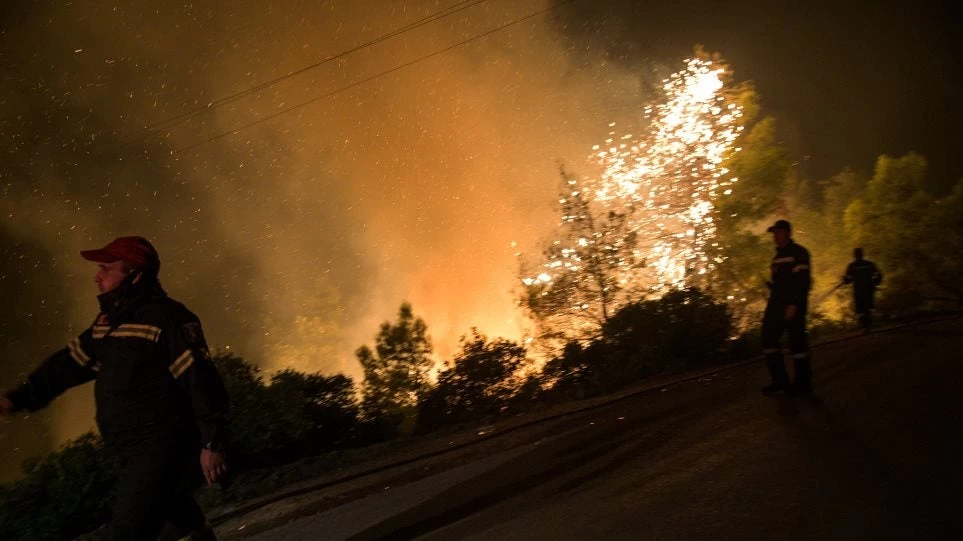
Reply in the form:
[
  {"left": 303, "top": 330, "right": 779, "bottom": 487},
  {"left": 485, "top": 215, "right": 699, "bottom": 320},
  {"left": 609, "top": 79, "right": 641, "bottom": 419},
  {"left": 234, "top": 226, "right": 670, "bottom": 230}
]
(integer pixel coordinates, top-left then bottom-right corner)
[{"left": 0, "top": 237, "right": 227, "bottom": 541}]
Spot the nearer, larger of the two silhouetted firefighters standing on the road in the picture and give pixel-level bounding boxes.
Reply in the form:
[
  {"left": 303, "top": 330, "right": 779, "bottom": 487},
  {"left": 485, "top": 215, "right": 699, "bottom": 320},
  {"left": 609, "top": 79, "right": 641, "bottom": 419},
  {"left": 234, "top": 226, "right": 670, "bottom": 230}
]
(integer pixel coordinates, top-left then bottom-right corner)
[{"left": 762, "top": 220, "right": 812, "bottom": 395}]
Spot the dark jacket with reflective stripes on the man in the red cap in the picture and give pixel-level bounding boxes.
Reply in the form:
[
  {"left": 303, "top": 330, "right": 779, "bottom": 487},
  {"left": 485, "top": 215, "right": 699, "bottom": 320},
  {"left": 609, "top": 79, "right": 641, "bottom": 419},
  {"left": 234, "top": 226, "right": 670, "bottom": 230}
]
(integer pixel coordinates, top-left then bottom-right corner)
[{"left": 7, "top": 281, "right": 227, "bottom": 450}]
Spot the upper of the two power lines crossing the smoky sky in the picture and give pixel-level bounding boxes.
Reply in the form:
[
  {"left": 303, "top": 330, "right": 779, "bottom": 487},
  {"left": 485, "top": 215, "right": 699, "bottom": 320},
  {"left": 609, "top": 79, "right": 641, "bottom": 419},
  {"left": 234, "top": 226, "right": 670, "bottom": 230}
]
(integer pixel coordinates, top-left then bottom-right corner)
[{"left": 125, "top": 0, "right": 488, "bottom": 146}]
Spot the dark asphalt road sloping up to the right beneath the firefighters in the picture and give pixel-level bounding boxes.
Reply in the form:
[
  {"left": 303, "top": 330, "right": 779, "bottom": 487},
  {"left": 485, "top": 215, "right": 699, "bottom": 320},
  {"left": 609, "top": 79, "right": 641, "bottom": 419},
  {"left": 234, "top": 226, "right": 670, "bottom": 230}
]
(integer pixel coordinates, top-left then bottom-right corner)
[{"left": 254, "top": 319, "right": 963, "bottom": 541}]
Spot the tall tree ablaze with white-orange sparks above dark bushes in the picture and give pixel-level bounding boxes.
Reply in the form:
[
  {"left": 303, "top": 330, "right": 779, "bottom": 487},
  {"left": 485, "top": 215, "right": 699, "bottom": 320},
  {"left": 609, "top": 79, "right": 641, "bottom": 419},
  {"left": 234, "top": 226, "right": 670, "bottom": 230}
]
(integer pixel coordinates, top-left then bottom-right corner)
[{"left": 522, "top": 51, "right": 752, "bottom": 345}]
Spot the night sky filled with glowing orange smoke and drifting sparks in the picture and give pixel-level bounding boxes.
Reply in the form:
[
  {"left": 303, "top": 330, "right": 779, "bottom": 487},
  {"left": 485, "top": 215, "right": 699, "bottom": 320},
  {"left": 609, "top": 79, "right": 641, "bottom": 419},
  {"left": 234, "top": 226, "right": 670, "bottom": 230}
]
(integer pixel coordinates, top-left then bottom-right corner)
[{"left": 0, "top": 0, "right": 963, "bottom": 475}]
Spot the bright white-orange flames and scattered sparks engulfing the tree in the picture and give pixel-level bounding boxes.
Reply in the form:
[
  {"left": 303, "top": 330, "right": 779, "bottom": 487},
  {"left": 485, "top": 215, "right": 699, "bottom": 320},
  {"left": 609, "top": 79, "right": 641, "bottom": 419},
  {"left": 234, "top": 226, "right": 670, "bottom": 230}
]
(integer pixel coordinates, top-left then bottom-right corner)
[{"left": 522, "top": 58, "right": 743, "bottom": 310}]
